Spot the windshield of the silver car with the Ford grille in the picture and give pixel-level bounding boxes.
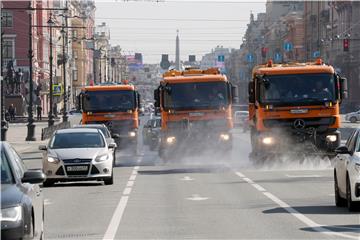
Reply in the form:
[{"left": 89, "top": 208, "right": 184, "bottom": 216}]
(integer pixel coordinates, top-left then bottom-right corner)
[{"left": 50, "top": 132, "right": 105, "bottom": 149}]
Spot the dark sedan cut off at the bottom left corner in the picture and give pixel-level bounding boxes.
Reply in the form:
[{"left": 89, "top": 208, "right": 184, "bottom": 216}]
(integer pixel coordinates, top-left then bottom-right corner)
[{"left": 0, "top": 142, "right": 45, "bottom": 239}]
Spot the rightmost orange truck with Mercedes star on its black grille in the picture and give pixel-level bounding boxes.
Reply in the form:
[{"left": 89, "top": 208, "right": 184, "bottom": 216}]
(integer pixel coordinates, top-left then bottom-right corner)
[{"left": 249, "top": 59, "right": 347, "bottom": 159}]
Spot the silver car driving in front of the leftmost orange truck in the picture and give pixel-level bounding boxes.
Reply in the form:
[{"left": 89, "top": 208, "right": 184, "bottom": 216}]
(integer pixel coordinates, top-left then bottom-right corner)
[{"left": 39, "top": 128, "right": 116, "bottom": 187}]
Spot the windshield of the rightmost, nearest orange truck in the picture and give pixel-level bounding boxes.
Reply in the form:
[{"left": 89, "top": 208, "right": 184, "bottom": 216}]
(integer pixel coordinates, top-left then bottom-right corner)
[{"left": 259, "top": 73, "right": 336, "bottom": 105}]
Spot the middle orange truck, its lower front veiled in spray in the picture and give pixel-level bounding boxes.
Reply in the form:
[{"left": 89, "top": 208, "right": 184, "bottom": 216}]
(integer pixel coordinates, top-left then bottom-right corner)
[{"left": 154, "top": 68, "right": 237, "bottom": 159}]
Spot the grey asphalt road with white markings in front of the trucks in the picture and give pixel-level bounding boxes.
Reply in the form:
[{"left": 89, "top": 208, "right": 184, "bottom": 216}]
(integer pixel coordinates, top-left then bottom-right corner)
[{"left": 13, "top": 118, "right": 360, "bottom": 239}]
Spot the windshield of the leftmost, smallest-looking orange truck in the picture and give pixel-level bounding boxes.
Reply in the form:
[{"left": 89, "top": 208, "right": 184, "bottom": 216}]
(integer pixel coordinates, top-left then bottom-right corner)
[{"left": 83, "top": 90, "right": 136, "bottom": 112}]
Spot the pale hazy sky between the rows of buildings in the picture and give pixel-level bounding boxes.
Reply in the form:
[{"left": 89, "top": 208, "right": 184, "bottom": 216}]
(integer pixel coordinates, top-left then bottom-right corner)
[{"left": 96, "top": 0, "right": 265, "bottom": 63}]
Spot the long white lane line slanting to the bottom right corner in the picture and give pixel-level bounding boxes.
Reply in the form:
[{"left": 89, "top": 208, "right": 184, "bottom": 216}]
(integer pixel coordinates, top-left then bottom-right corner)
[{"left": 235, "top": 172, "right": 358, "bottom": 239}]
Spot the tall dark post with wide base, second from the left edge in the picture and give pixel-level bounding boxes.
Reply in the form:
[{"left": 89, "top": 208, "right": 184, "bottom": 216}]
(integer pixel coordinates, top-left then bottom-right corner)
[{"left": 25, "top": 5, "right": 36, "bottom": 141}]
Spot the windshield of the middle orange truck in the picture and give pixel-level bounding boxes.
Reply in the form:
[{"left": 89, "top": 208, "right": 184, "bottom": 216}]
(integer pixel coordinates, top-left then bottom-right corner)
[{"left": 164, "top": 82, "right": 229, "bottom": 110}]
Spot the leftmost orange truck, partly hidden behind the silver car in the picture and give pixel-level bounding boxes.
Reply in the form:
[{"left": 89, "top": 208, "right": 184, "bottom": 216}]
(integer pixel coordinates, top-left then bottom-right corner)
[{"left": 78, "top": 84, "right": 140, "bottom": 151}]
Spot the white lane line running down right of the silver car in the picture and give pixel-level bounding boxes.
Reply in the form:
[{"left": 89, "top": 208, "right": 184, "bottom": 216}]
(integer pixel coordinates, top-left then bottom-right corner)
[{"left": 103, "top": 157, "right": 141, "bottom": 240}]
